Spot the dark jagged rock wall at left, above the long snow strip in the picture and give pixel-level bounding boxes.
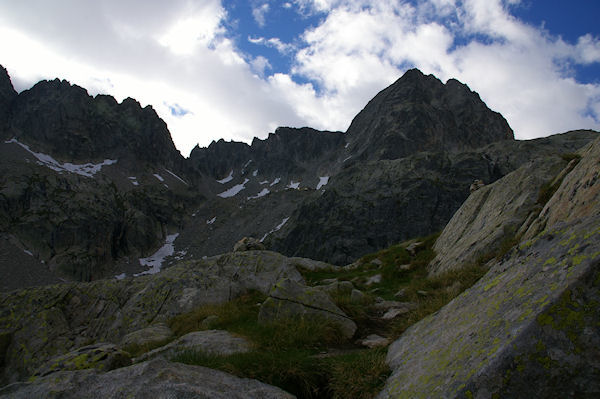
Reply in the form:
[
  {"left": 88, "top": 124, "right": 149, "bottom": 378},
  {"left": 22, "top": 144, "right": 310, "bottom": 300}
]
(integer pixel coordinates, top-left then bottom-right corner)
[{"left": 9, "top": 79, "right": 183, "bottom": 173}]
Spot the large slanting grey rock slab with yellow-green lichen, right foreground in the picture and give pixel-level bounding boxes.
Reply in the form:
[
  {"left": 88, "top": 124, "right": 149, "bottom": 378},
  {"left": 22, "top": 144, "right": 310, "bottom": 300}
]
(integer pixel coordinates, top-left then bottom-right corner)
[{"left": 379, "top": 140, "right": 600, "bottom": 398}]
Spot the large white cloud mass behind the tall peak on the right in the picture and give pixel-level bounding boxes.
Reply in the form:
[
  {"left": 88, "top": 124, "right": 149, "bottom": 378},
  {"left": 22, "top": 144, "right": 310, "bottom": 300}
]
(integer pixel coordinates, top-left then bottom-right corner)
[{"left": 293, "top": 0, "right": 600, "bottom": 138}]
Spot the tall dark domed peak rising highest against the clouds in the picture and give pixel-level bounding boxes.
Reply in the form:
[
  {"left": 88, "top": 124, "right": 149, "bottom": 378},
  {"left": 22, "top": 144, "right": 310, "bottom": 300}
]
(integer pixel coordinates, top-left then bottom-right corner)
[{"left": 346, "top": 69, "right": 513, "bottom": 159}]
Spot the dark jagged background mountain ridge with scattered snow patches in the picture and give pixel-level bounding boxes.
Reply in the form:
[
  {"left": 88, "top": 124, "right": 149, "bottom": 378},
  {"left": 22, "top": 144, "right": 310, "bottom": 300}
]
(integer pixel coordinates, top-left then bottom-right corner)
[{"left": 0, "top": 65, "right": 594, "bottom": 289}]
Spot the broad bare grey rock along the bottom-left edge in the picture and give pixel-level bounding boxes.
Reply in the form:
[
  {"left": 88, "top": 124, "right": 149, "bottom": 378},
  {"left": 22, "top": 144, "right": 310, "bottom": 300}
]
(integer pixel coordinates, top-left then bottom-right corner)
[{"left": 0, "top": 359, "right": 294, "bottom": 399}]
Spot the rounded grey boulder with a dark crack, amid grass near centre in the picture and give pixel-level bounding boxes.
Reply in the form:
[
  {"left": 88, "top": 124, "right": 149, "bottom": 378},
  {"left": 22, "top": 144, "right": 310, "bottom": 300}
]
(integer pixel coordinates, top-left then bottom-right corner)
[{"left": 258, "top": 279, "right": 357, "bottom": 338}]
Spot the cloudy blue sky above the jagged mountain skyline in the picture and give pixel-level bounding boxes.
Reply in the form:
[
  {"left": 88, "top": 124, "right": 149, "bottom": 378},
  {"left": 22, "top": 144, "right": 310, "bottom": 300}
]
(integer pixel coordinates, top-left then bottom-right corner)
[{"left": 0, "top": 0, "right": 600, "bottom": 157}]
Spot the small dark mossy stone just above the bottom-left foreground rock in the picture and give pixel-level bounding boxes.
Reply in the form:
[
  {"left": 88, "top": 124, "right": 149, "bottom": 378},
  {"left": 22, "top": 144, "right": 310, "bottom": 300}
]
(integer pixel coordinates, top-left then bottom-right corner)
[{"left": 33, "top": 343, "right": 131, "bottom": 377}]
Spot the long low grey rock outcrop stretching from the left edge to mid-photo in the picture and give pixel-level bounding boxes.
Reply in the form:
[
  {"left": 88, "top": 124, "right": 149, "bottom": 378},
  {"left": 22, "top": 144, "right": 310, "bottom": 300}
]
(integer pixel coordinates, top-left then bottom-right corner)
[{"left": 0, "top": 251, "right": 303, "bottom": 382}]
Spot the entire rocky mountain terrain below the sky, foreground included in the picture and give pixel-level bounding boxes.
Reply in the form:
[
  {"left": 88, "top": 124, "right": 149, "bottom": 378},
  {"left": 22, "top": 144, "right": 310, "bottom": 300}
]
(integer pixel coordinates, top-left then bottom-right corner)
[{"left": 0, "top": 64, "right": 600, "bottom": 398}]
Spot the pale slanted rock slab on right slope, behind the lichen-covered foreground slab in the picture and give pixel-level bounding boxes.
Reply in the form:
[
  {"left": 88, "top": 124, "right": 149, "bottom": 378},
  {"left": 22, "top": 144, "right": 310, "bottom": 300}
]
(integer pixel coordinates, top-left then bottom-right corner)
[{"left": 428, "top": 157, "right": 567, "bottom": 275}]
